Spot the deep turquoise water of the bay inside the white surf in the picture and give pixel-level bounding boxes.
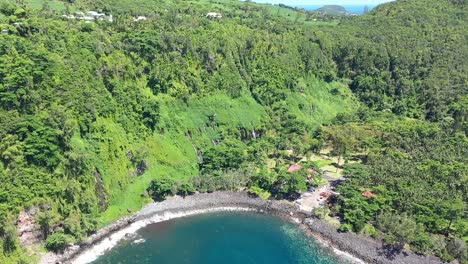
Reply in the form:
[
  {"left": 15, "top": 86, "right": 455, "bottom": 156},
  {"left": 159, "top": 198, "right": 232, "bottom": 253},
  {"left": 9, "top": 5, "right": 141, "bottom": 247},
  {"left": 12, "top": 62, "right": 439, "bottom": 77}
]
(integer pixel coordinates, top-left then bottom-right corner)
[{"left": 93, "top": 212, "right": 348, "bottom": 264}]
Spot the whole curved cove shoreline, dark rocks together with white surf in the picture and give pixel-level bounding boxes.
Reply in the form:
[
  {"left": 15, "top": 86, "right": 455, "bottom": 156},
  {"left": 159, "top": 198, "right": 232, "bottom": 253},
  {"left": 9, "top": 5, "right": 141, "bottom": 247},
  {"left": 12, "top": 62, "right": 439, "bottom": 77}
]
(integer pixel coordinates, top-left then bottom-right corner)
[{"left": 39, "top": 191, "right": 443, "bottom": 264}]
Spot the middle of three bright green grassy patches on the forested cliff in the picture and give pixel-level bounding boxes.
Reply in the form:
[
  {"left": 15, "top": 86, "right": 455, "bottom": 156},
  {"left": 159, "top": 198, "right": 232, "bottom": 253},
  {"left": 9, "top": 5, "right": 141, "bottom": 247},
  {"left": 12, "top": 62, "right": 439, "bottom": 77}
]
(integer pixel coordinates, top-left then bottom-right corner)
[{"left": 158, "top": 93, "right": 269, "bottom": 146}]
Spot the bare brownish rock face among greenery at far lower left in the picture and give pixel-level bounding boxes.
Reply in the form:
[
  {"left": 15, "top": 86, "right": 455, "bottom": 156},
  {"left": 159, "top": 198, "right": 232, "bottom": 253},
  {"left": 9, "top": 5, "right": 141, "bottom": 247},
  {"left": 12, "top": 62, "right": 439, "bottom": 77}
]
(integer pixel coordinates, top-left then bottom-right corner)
[{"left": 16, "top": 207, "right": 42, "bottom": 246}]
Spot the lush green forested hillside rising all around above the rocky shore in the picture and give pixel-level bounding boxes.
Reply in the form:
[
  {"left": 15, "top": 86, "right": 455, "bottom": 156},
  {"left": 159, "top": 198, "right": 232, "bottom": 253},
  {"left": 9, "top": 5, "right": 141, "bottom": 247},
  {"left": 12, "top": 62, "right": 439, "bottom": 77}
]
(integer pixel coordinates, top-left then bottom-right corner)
[{"left": 0, "top": 0, "right": 468, "bottom": 263}]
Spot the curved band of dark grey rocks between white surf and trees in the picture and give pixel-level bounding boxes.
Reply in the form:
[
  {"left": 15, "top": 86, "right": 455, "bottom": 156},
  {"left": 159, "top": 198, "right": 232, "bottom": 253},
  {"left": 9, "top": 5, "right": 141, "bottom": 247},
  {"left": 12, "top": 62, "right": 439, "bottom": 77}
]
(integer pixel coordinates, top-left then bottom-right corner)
[{"left": 41, "top": 192, "right": 442, "bottom": 264}]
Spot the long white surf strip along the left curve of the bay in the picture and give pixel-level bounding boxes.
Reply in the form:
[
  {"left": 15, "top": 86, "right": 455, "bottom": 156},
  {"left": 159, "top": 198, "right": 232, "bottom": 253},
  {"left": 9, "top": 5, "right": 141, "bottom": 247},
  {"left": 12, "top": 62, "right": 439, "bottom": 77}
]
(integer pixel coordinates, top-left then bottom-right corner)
[{"left": 72, "top": 207, "right": 258, "bottom": 264}]
